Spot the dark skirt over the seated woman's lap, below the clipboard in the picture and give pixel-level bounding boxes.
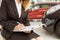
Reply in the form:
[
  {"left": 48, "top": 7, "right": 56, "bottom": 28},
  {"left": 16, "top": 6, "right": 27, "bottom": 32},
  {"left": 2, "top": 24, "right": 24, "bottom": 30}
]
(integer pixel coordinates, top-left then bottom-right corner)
[{"left": 7, "top": 32, "right": 39, "bottom": 40}]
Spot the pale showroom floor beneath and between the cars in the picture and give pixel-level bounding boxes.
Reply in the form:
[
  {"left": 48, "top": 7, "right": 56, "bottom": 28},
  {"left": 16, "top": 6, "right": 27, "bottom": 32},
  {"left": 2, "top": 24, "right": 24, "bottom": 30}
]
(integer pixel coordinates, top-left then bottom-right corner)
[{"left": 0, "top": 22, "right": 60, "bottom": 40}]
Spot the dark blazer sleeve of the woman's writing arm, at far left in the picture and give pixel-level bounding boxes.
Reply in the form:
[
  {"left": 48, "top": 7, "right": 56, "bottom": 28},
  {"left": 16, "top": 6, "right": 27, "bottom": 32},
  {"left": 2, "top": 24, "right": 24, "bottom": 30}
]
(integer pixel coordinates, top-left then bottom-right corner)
[{"left": 0, "top": 0, "right": 18, "bottom": 33}]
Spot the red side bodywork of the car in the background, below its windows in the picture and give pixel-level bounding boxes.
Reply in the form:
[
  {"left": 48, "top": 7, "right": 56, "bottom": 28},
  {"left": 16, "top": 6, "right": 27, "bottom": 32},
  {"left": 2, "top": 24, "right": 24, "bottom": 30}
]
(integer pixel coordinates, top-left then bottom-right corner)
[{"left": 29, "top": 8, "right": 48, "bottom": 19}]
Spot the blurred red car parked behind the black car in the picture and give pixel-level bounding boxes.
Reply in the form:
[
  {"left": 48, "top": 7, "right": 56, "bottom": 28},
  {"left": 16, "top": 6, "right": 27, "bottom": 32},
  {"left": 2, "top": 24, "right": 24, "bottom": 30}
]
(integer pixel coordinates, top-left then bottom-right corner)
[{"left": 29, "top": 2, "right": 60, "bottom": 20}]
